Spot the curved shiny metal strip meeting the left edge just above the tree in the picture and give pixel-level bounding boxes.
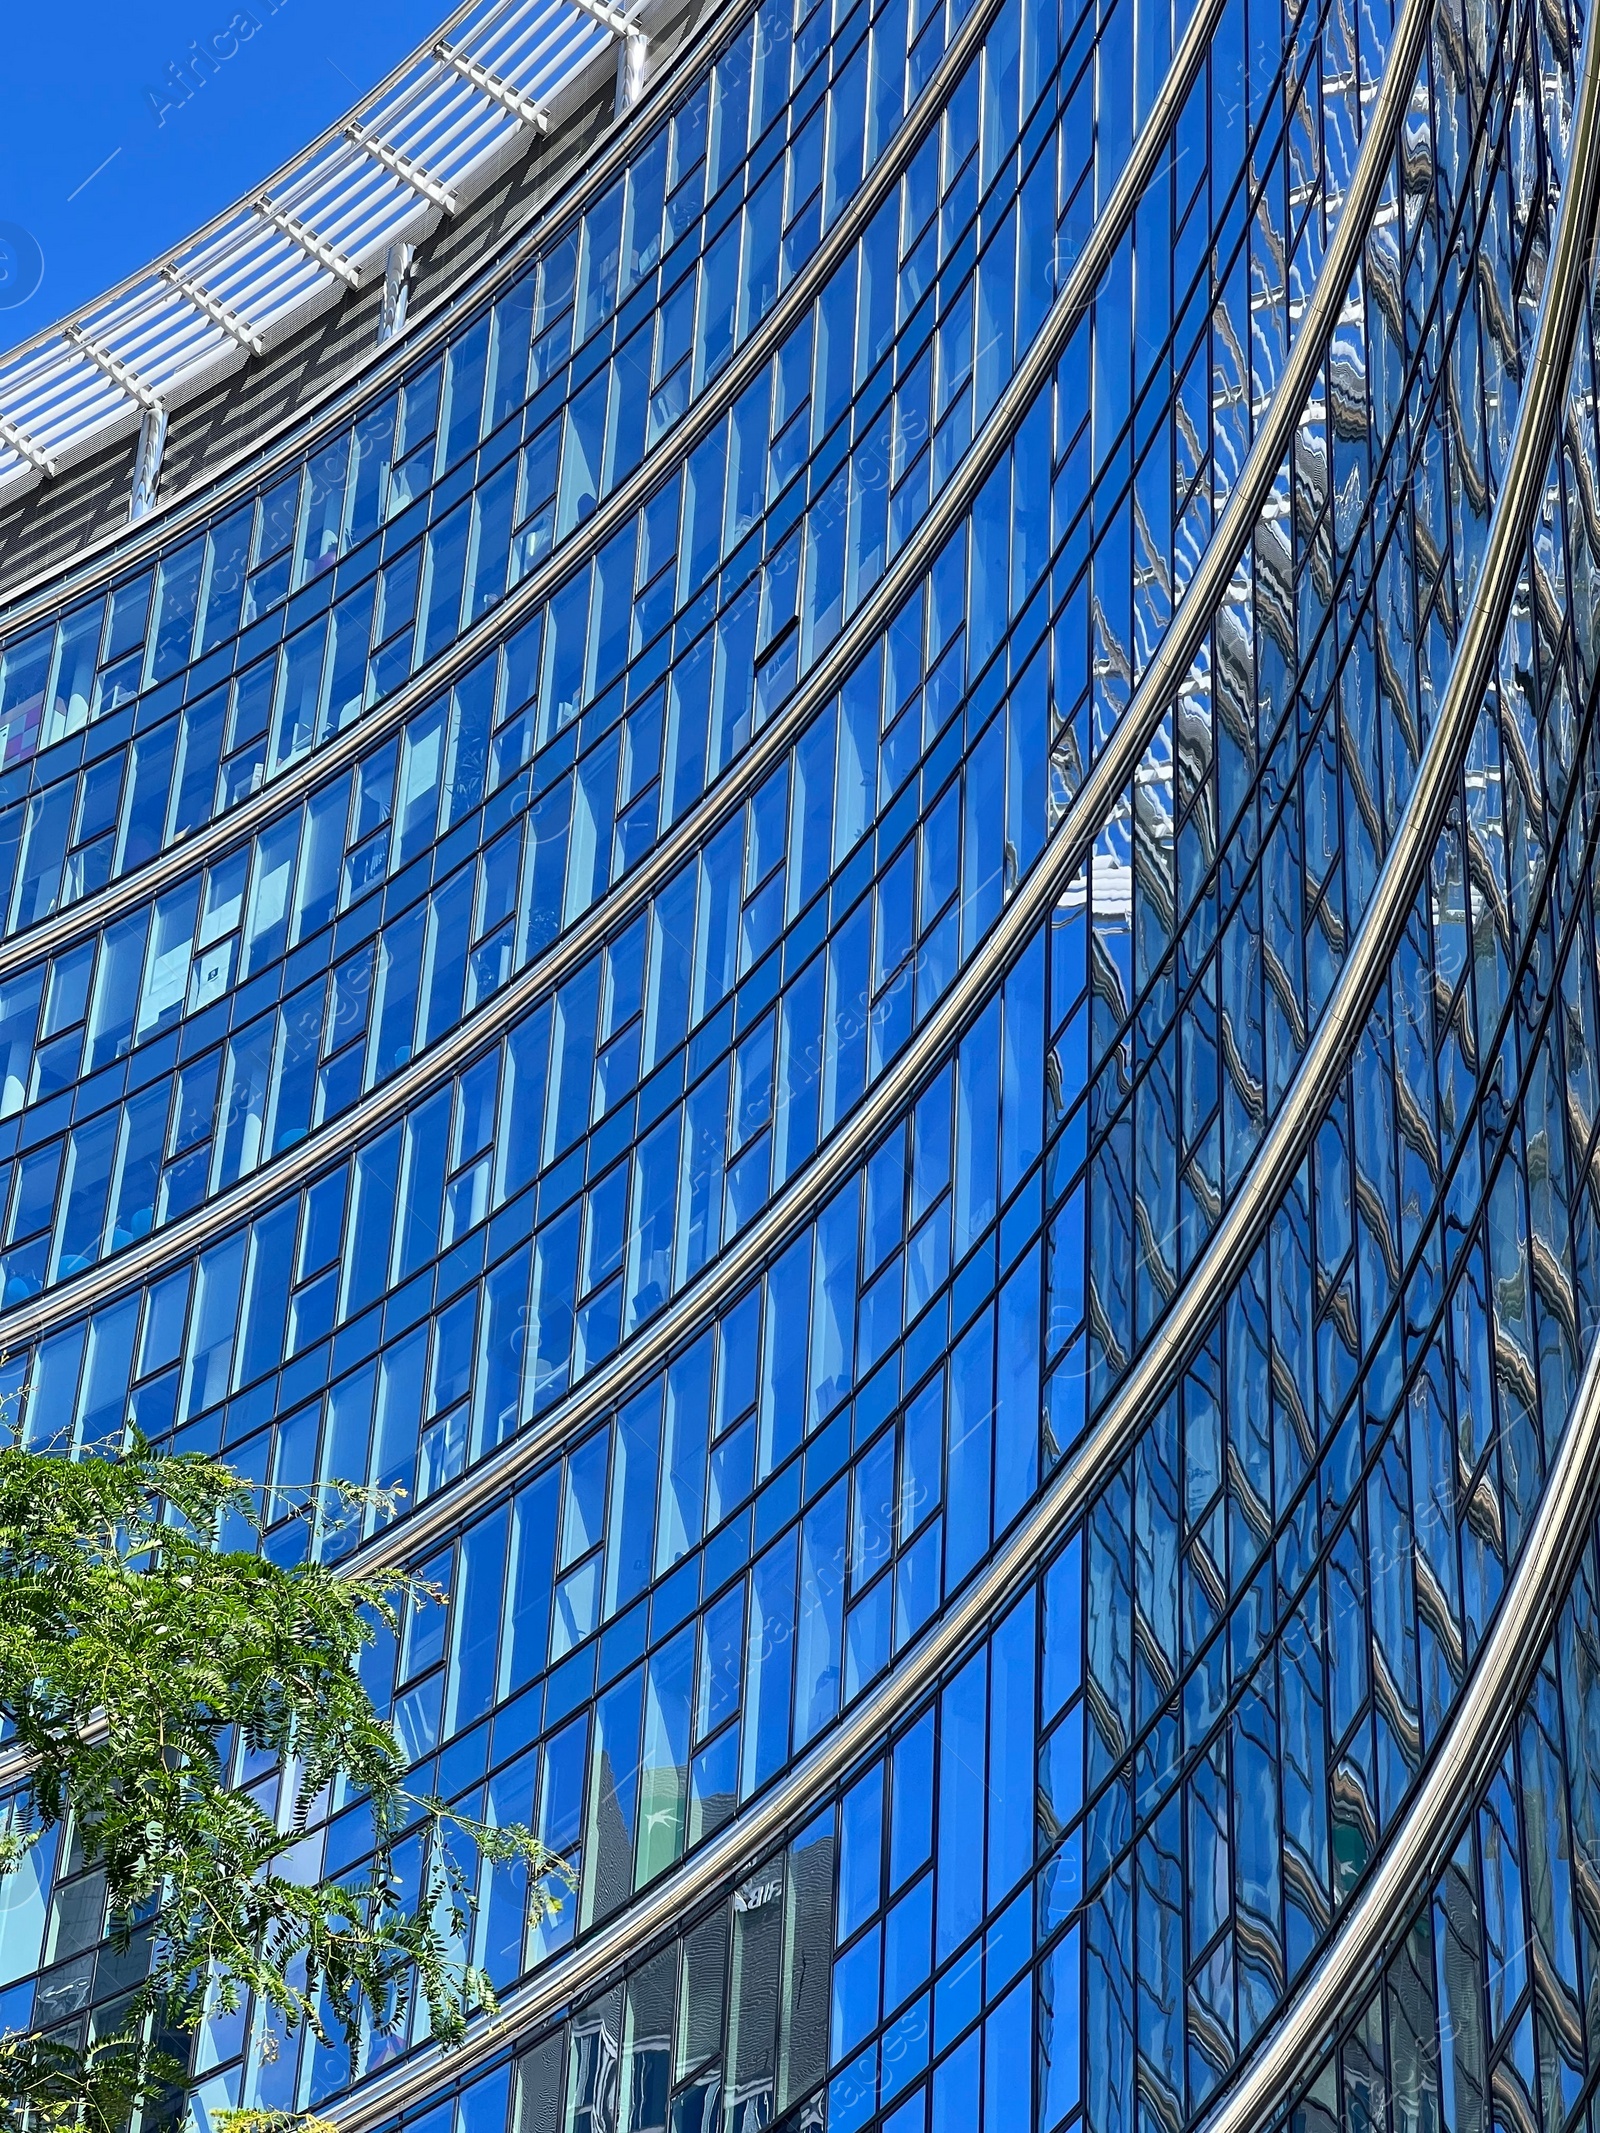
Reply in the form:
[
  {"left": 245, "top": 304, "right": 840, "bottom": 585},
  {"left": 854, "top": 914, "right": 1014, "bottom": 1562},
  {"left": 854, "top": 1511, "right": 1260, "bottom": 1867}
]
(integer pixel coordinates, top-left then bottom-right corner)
[{"left": 0, "top": 0, "right": 1237, "bottom": 1339}]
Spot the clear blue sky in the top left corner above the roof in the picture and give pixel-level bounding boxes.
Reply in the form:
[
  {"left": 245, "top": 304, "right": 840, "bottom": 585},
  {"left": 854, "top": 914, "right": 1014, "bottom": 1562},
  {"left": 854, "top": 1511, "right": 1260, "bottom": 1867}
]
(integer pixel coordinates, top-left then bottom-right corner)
[{"left": 0, "top": 0, "right": 452, "bottom": 350}]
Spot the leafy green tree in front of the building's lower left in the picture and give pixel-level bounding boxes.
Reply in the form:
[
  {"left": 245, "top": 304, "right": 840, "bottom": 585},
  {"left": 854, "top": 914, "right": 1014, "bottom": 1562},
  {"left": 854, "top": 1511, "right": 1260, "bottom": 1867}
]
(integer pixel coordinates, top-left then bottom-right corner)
[{"left": 0, "top": 1440, "right": 572, "bottom": 2133}]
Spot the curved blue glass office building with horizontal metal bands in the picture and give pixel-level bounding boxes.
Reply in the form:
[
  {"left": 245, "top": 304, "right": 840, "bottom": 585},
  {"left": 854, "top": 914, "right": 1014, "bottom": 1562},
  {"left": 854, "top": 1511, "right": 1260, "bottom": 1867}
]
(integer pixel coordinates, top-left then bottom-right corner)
[{"left": 0, "top": 0, "right": 1600, "bottom": 2133}]
